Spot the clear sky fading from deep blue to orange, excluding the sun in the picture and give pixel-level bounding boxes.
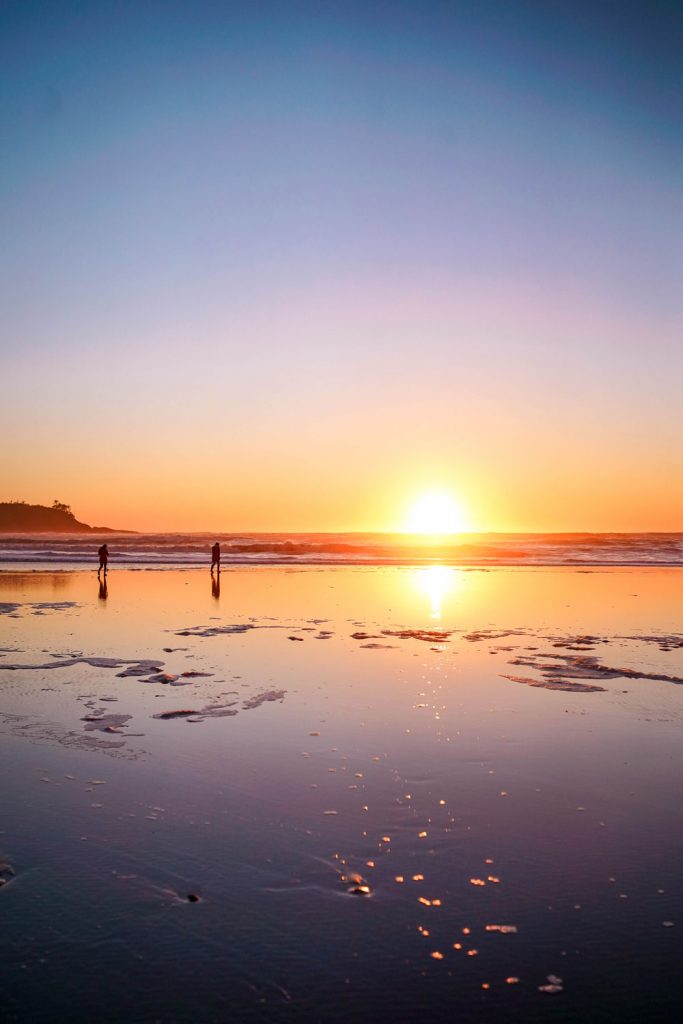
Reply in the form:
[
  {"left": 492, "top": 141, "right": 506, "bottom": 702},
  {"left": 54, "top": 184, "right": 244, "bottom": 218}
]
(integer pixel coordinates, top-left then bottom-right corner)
[{"left": 0, "top": 0, "right": 683, "bottom": 531}]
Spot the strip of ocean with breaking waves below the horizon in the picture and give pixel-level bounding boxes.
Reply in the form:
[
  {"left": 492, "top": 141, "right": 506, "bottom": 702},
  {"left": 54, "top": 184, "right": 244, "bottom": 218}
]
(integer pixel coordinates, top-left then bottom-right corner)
[{"left": 0, "top": 534, "right": 683, "bottom": 568}]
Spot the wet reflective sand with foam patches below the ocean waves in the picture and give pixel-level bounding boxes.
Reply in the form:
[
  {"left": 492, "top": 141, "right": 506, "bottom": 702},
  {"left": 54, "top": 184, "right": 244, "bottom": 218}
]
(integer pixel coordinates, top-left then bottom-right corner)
[{"left": 0, "top": 566, "right": 683, "bottom": 1024}]
